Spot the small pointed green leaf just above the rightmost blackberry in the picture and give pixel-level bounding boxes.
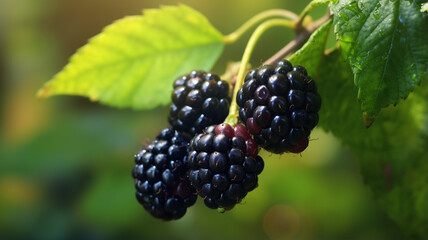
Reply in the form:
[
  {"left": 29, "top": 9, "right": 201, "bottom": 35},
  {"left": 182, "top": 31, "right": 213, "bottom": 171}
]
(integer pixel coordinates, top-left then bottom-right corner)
[{"left": 289, "top": 20, "right": 332, "bottom": 74}]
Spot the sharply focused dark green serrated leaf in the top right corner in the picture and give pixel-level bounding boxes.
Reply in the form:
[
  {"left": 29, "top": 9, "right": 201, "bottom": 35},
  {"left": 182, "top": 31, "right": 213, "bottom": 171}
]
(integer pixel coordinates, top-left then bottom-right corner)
[{"left": 331, "top": 0, "right": 428, "bottom": 118}]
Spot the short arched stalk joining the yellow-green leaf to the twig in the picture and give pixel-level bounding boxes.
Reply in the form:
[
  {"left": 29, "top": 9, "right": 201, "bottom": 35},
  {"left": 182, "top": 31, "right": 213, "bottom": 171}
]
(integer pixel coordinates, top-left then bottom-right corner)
[{"left": 223, "top": 9, "right": 299, "bottom": 44}]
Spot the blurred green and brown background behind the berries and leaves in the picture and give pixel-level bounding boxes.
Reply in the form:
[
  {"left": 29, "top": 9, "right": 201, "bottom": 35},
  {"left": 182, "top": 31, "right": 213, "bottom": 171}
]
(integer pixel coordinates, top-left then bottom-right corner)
[{"left": 0, "top": 0, "right": 404, "bottom": 240}]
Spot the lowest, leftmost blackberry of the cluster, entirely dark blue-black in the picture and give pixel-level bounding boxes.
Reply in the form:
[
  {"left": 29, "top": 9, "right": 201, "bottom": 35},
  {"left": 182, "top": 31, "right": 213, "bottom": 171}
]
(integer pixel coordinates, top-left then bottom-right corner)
[{"left": 132, "top": 128, "right": 197, "bottom": 220}]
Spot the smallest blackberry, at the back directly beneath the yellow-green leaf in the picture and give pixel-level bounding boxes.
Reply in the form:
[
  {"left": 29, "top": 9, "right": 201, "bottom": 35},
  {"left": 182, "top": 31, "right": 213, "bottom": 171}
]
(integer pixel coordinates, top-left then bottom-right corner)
[{"left": 168, "top": 71, "right": 230, "bottom": 137}]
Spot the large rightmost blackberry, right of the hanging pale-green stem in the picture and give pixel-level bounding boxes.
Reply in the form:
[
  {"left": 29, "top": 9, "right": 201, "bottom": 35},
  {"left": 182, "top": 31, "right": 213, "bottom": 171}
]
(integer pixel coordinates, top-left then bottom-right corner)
[{"left": 236, "top": 60, "right": 321, "bottom": 153}]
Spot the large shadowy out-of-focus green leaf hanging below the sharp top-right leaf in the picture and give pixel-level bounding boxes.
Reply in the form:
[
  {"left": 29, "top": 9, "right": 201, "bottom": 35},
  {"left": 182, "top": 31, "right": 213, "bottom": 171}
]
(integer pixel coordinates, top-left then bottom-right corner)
[{"left": 318, "top": 51, "right": 428, "bottom": 239}]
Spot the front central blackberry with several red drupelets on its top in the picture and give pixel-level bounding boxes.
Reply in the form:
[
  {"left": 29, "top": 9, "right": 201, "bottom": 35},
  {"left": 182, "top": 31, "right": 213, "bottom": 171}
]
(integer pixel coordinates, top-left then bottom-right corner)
[{"left": 187, "top": 123, "right": 264, "bottom": 209}]
